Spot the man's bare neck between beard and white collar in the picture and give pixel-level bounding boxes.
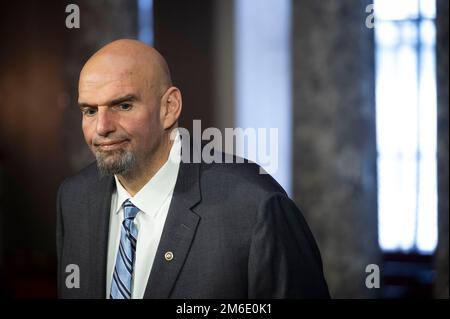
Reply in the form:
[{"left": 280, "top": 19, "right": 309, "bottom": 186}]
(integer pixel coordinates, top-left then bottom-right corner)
[{"left": 117, "top": 139, "right": 173, "bottom": 196}]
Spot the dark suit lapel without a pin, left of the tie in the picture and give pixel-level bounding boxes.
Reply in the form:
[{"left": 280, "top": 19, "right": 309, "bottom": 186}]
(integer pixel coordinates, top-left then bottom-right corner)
[{"left": 88, "top": 172, "right": 114, "bottom": 298}]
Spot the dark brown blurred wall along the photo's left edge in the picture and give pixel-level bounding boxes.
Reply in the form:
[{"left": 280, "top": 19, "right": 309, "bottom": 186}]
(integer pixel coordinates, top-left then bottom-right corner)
[{"left": 0, "top": 1, "right": 70, "bottom": 297}]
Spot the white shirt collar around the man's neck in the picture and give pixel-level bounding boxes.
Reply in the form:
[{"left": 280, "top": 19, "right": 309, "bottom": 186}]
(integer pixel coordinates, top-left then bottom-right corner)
[{"left": 114, "top": 130, "right": 181, "bottom": 214}]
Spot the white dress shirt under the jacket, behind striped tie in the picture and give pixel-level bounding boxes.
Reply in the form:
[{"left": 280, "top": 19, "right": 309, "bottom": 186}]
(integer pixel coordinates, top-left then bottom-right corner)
[{"left": 106, "top": 132, "right": 181, "bottom": 299}]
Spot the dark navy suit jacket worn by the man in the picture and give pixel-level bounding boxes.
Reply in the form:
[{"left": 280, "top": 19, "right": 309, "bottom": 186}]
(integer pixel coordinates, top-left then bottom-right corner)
[{"left": 56, "top": 154, "right": 329, "bottom": 299}]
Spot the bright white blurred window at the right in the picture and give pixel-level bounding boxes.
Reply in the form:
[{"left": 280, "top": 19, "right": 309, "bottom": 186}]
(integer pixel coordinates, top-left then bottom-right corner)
[{"left": 374, "top": 0, "right": 437, "bottom": 253}]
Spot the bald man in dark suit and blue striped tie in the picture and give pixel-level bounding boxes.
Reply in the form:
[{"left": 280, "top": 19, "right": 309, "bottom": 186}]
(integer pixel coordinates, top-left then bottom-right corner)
[{"left": 57, "top": 40, "right": 329, "bottom": 299}]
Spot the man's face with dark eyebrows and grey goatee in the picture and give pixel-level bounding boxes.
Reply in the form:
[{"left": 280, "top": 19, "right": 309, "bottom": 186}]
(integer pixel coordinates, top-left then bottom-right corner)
[{"left": 78, "top": 58, "right": 163, "bottom": 174}]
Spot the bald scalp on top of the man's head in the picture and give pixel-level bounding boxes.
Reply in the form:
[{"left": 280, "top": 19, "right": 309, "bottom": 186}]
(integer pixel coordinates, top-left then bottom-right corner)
[{"left": 80, "top": 39, "right": 172, "bottom": 94}]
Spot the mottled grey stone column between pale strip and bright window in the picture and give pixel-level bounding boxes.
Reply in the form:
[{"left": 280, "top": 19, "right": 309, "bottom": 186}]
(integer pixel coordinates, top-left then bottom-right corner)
[{"left": 293, "top": 0, "right": 380, "bottom": 298}]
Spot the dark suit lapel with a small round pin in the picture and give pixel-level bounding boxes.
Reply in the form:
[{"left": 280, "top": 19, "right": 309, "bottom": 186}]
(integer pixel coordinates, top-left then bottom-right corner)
[{"left": 144, "top": 163, "right": 200, "bottom": 298}]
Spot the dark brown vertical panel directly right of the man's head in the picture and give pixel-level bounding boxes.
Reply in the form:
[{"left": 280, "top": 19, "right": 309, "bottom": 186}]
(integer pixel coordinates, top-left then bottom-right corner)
[{"left": 154, "top": 0, "right": 215, "bottom": 129}]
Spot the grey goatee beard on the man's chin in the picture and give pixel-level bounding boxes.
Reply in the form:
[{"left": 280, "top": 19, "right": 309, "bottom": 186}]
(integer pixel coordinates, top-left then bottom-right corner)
[{"left": 95, "top": 150, "right": 136, "bottom": 177}]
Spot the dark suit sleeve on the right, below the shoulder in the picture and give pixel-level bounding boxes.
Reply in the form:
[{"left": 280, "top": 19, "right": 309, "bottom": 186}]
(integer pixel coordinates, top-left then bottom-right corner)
[{"left": 248, "top": 193, "right": 330, "bottom": 299}]
